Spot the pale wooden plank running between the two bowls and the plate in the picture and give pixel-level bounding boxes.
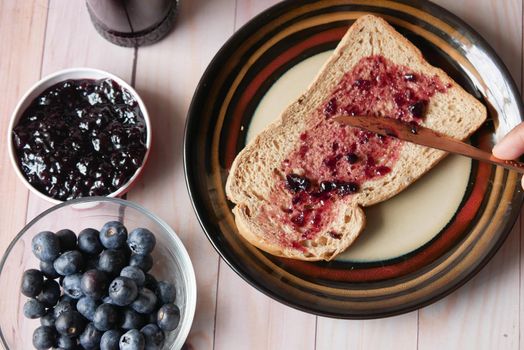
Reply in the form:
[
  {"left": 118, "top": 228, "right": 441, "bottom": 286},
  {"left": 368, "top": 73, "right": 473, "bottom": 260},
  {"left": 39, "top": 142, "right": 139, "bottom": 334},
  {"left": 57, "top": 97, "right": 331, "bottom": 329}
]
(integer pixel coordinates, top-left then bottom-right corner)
[{"left": 128, "top": 0, "right": 235, "bottom": 349}]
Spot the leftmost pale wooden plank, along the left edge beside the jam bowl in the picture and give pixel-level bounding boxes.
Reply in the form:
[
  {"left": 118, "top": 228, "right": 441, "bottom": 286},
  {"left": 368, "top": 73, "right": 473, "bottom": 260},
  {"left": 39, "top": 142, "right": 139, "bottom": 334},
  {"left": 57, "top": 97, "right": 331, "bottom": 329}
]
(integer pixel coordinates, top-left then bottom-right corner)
[{"left": 0, "top": 0, "right": 48, "bottom": 256}]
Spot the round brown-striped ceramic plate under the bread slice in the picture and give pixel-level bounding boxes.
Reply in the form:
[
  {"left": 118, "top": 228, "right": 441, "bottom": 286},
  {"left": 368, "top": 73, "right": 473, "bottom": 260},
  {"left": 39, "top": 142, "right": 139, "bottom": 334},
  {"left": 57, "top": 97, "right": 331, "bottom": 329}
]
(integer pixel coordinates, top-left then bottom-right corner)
[{"left": 185, "top": 0, "right": 523, "bottom": 318}]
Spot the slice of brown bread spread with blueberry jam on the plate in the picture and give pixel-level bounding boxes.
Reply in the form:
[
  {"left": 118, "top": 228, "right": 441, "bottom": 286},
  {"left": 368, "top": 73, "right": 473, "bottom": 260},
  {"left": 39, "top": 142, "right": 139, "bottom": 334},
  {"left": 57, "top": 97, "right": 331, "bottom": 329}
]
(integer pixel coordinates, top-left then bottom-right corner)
[{"left": 226, "top": 15, "right": 486, "bottom": 260}]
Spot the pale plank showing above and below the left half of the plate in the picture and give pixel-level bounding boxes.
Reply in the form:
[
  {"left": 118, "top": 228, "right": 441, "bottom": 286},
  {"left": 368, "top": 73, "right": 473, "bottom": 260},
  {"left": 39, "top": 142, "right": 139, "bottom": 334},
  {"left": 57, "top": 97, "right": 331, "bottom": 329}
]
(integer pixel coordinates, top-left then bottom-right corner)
[{"left": 215, "top": 0, "right": 316, "bottom": 350}]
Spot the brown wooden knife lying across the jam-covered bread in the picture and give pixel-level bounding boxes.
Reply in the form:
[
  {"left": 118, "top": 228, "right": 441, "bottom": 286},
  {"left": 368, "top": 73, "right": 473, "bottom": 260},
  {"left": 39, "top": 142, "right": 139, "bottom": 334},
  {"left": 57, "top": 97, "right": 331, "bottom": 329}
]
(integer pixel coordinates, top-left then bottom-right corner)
[{"left": 333, "top": 116, "right": 524, "bottom": 174}]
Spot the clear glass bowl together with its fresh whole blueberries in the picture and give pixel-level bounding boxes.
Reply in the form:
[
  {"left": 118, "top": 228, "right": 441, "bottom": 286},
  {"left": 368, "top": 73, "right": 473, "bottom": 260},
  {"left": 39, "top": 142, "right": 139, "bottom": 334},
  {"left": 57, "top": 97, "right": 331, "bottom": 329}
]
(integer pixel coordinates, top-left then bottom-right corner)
[{"left": 0, "top": 197, "right": 197, "bottom": 350}]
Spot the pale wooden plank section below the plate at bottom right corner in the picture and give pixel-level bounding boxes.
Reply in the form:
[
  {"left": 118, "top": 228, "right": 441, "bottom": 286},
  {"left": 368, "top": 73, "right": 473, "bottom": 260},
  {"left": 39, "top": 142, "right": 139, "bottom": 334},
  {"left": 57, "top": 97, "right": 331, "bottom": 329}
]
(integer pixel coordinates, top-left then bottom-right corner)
[{"left": 419, "top": 223, "right": 520, "bottom": 349}]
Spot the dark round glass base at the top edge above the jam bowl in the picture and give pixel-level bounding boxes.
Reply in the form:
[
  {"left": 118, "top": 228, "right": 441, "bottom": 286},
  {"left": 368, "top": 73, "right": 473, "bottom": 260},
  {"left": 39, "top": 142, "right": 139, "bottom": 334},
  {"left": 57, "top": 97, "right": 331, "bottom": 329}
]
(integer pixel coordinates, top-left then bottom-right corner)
[{"left": 86, "top": 0, "right": 178, "bottom": 47}]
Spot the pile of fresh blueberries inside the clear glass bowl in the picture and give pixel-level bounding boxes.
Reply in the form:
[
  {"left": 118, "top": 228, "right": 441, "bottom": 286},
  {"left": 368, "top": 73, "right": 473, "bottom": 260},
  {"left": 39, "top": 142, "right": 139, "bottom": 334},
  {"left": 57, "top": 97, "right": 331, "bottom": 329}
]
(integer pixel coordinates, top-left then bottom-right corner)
[{"left": 21, "top": 221, "right": 180, "bottom": 350}]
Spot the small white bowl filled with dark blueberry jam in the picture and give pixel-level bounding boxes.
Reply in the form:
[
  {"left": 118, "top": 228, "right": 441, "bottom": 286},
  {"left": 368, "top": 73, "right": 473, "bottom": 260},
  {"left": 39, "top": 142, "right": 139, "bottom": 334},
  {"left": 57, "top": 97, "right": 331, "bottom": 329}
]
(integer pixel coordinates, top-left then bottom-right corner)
[{"left": 7, "top": 68, "right": 151, "bottom": 203}]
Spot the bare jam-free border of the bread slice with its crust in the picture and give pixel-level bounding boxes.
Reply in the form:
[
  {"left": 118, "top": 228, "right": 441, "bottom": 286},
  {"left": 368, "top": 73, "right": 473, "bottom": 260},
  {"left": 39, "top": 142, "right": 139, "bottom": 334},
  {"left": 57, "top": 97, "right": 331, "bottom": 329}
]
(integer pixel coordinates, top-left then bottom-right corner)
[{"left": 226, "top": 15, "right": 486, "bottom": 261}]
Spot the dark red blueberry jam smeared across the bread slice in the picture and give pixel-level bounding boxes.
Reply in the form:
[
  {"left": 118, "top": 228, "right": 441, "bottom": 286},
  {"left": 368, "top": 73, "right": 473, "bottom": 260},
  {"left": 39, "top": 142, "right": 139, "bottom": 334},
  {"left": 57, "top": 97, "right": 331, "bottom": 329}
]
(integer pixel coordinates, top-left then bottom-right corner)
[{"left": 267, "top": 56, "right": 451, "bottom": 249}]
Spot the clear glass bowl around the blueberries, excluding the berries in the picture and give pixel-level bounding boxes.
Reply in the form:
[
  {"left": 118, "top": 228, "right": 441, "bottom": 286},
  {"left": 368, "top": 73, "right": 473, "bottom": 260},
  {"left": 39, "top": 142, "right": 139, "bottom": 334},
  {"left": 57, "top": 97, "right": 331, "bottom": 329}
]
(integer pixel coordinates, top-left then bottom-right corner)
[{"left": 0, "top": 197, "right": 196, "bottom": 350}]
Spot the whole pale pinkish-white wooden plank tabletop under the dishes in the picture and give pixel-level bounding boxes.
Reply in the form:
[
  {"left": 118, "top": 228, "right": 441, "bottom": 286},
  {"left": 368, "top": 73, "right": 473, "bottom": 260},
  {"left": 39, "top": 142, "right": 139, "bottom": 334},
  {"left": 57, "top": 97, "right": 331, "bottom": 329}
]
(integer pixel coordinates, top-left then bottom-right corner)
[{"left": 0, "top": 0, "right": 524, "bottom": 350}]
